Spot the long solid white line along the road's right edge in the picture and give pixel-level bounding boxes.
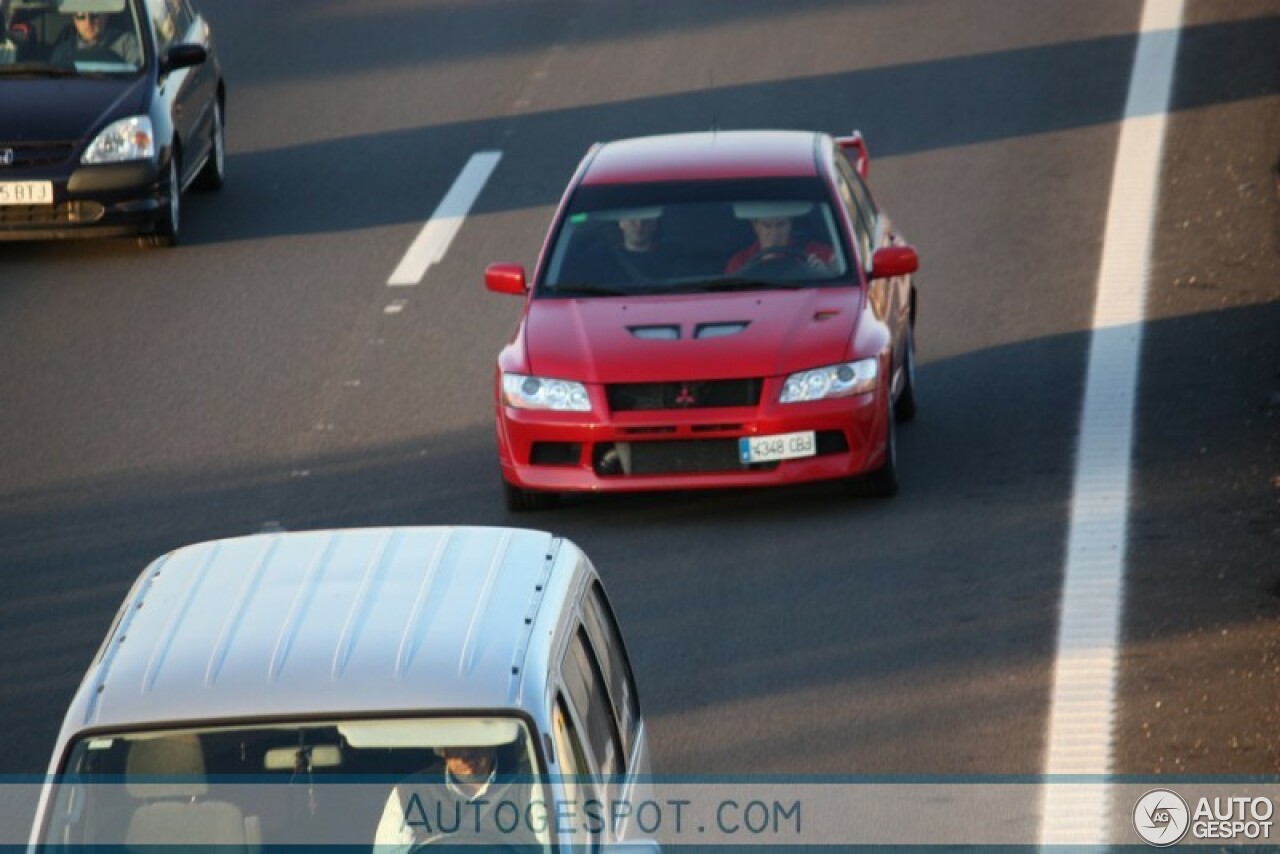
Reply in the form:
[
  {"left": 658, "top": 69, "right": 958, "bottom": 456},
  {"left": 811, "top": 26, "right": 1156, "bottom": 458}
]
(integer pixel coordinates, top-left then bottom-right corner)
[{"left": 1041, "top": 0, "right": 1184, "bottom": 845}]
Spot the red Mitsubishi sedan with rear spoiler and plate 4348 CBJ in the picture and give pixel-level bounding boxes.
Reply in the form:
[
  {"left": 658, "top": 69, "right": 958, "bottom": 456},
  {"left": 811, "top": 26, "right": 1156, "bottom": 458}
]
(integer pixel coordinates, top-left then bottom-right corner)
[{"left": 485, "top": 131, "right": 919, "bottom": 511}]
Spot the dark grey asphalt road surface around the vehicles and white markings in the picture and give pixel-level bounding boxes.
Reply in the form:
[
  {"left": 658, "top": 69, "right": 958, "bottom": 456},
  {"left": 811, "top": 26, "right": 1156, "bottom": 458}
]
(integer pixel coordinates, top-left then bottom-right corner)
[{"left": 0, "top": 0, "right": 1280, "bottom": 814}]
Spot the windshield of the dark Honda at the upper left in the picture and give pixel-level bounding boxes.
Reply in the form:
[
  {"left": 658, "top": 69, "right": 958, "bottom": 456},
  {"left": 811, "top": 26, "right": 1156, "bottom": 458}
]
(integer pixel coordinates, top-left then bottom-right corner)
[{"left": 0, "top": 0, "right": 146, "bottom": 77}]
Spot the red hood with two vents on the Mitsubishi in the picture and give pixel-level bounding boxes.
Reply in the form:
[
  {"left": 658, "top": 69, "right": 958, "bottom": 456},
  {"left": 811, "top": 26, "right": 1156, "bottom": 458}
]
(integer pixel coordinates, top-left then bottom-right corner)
[{"left": 525, "top": 288, "right": 860, "bottom": 383}]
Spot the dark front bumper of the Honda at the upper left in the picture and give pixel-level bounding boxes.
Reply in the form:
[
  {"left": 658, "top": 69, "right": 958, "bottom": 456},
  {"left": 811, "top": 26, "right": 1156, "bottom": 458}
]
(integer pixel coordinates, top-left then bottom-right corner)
[{"left": 0, "top": 161, "right": 169, "bottom": 241}]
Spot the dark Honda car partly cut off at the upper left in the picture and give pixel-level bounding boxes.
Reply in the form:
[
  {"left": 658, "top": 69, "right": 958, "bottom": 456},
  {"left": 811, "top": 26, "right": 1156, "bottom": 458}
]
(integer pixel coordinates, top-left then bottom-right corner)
[{"left": 0, "top": 0, "right": 227, "bottom": 246}]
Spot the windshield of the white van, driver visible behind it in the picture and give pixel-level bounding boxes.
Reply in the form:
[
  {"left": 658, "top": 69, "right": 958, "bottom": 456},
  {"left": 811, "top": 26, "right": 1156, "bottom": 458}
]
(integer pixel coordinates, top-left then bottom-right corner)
[{"left": 42, "top": 716, "right": 550, "bottom": 850}]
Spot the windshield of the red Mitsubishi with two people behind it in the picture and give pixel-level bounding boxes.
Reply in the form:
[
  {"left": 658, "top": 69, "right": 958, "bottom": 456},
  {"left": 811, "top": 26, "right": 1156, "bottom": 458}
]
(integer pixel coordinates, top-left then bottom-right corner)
[{"left": 538, "top": 178, "right": 850, "bottom": 297}]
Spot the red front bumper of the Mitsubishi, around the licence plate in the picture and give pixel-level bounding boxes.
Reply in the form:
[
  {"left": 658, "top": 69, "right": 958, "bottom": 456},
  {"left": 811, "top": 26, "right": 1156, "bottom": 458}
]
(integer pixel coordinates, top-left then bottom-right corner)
[{"left": 498, "top": 388, "right": 890, "bottom": 492}]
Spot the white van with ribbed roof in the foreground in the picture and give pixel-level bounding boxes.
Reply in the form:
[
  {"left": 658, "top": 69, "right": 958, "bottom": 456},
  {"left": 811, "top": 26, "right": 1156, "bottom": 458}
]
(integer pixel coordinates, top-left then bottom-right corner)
[{"left": 31, "top": 528, "right": 652, "bottom": 851}]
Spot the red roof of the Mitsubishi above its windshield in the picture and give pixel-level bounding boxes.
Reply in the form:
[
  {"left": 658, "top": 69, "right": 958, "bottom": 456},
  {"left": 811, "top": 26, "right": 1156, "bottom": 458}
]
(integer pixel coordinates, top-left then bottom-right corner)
[{"left": 582, "top": 131, "right": 820, "bottom": 184}]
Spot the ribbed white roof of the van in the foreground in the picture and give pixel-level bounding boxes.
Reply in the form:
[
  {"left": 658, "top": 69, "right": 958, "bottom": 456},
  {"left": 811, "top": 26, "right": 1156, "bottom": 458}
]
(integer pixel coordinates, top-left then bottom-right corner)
[{"left": 63, "top": 528, "right": 586, "bottom": 739}]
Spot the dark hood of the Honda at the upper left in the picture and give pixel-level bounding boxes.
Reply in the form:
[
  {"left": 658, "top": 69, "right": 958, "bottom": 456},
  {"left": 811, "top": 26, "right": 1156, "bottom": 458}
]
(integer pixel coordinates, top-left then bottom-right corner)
[{"left": 0, "top": 74, "right": 147, "bottom": 142}]
